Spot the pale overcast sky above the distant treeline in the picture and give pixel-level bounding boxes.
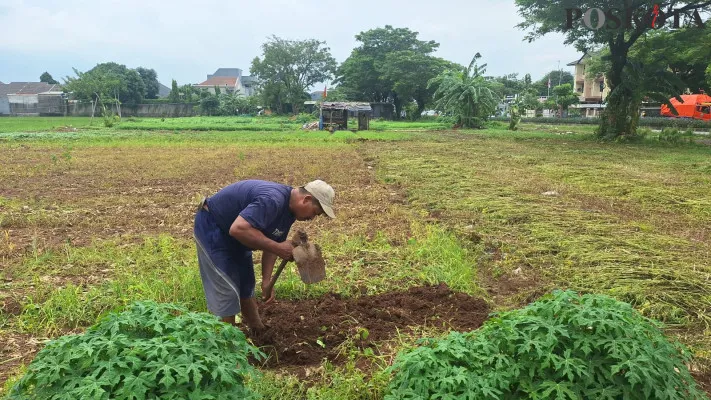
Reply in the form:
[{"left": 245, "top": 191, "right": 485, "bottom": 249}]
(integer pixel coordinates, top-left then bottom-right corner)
[{"left": 0, "top": 0, "right": 579, "bottom": 86}]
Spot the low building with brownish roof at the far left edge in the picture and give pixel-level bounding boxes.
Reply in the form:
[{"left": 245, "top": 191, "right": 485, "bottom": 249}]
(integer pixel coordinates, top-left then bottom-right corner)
[{"left": 0, "top": 82, "right": 67, "bottom": 115}]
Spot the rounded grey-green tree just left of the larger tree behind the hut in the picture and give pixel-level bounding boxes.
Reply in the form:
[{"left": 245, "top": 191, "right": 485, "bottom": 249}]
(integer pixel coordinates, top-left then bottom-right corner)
[{"left": 249, "top": 36, "right": 336, "bottom": 113}]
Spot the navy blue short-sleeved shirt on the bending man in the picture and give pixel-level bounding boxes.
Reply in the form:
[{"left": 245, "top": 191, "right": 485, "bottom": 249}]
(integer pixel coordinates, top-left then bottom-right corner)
[{"left": 207, "top": 180, "right": 296, "bottom": 250}]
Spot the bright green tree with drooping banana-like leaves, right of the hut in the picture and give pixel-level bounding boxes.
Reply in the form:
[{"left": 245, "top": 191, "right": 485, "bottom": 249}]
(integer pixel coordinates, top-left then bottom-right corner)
[{"left": 430, "top": 53, "right": 498, "bottom": 128}]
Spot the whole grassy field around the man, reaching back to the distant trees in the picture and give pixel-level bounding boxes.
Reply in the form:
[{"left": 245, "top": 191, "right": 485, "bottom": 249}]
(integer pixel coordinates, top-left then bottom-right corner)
[{"left": 0, "top": 117, "right": 711, "bottom": 399}]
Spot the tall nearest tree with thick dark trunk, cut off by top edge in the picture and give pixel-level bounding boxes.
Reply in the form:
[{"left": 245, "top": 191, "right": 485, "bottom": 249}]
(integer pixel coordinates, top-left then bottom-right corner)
[{"left": 516, "top": 0, "right": 711, "bottom": 138}]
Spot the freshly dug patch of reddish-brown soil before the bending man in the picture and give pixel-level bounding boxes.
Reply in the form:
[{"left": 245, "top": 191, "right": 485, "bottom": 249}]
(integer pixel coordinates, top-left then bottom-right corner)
[{"left": 250, "top": 284, "right": 489, "bottom": 368}]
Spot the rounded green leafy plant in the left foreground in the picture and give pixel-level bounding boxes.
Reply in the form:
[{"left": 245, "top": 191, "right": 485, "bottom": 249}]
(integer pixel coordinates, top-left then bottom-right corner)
[{"left": 9, "top": 301, "right": 264, "bottom": 400}]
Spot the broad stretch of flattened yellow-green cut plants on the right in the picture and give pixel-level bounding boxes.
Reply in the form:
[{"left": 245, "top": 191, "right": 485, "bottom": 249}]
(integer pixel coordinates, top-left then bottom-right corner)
[{"left": 371, "top": 128, "right": 711, "bottom": 329}]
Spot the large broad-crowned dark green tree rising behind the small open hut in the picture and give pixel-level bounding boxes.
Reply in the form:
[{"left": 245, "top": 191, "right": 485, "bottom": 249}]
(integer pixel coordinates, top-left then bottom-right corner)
[{"left": 336, "top": 25, "right": 441, "bottom": 116}]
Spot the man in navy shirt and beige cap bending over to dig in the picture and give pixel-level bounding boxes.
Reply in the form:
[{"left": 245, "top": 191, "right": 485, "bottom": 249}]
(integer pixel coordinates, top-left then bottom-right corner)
[{"left": 194, "top": 180, "right": 335, "bottom": 331}]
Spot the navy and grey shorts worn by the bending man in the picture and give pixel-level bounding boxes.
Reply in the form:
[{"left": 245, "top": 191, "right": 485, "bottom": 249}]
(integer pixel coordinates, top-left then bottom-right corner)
[{"left": 195, "top": 211, "right": 255, "bottom": 317}]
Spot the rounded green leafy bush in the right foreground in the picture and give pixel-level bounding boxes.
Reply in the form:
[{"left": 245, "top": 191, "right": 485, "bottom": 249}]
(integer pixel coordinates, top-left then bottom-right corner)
[{"left": 385, "top": 291, "right": 706, "bottom": 400}]
